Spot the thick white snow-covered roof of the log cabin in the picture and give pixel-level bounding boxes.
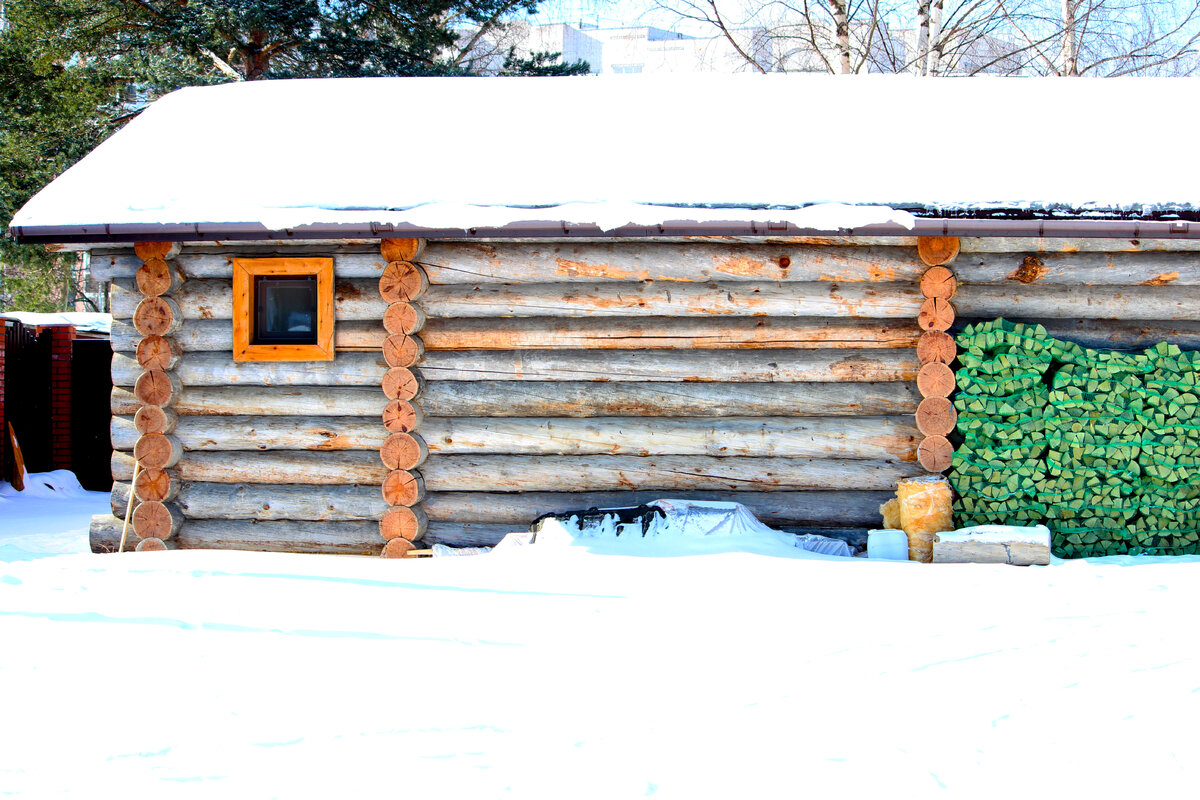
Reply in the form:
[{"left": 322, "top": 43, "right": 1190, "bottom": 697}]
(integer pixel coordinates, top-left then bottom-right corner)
[{"left": 12, "top": 74, "right": 1200, "bottom": 241}]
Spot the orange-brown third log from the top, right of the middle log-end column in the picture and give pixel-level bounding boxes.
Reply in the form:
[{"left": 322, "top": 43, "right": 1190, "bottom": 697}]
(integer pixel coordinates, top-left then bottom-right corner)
[{"left": 417, "top": 317, "right": 920, "bottom": 350}]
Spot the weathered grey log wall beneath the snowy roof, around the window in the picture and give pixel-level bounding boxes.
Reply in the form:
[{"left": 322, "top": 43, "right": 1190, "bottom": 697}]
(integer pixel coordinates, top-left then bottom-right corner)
[{"left": 92, "top": 240, "right": 1200, "bottom": 553}]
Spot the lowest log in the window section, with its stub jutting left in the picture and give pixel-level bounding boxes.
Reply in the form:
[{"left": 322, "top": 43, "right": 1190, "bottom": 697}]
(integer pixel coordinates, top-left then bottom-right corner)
[{"left": 90, "top": 515, "right": 383, "bottom": 555}]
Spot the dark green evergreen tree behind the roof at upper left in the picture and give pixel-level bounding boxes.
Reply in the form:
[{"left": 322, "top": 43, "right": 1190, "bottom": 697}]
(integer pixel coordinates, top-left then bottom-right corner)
[{"left": 0, "top": 0, "right": 587, "bottom": 311}]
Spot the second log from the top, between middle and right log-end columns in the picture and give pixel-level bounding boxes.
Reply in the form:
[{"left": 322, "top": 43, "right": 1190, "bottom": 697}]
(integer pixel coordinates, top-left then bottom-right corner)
[{"left": 421, "top": 281, "right": 922, "bottom": 319}]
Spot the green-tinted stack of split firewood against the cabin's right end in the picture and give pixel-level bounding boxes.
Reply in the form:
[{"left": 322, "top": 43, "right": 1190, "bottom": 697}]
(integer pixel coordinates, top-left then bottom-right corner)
[{"left": 952, "top": 320, "right": 1200, "bottom": 557}]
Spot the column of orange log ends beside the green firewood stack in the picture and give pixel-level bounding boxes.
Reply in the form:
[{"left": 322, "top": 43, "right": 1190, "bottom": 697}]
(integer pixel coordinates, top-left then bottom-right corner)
[{"left": 916, "top": 236, "right": 959, "bottom": 473}]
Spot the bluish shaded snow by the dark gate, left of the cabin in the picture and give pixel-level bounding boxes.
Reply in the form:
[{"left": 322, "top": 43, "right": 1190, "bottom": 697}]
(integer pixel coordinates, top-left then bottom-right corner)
[{"left": 0, "top": 469, "right": 109, "bottom": 561}]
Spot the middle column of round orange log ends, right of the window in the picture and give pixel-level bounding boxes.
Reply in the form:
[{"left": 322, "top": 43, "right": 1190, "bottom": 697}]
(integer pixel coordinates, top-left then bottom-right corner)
[{"left": 379, "top": 239, "right": 430, "bottom": 558}]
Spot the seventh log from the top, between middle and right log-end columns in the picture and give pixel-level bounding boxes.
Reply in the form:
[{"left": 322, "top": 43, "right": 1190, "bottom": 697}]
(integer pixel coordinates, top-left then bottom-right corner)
[{"left": 420, "top": 456, "right": 923, "bottom": 493}]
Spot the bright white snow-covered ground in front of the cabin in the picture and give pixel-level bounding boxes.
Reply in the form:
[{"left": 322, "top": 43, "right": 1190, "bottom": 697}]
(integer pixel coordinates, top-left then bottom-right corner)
[{"left": 0, "top": 479, "right": 1200, "bottom": 800}]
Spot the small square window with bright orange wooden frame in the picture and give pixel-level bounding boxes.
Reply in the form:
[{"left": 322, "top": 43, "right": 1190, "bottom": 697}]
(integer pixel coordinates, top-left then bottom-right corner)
[{"left": 233, "top": 258, "right": 334, "bottom": 361}]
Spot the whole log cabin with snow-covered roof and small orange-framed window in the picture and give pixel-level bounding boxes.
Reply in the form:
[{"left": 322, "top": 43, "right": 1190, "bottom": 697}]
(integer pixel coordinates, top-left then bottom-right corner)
[{"left": 11, "top": 76, "right": 1200, "bottom": 557}]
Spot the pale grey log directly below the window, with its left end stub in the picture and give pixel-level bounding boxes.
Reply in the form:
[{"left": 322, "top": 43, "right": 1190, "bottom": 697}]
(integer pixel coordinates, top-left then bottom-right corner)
[{"left": 113, "top": 350, "right": 388, "bottom": 387}]
